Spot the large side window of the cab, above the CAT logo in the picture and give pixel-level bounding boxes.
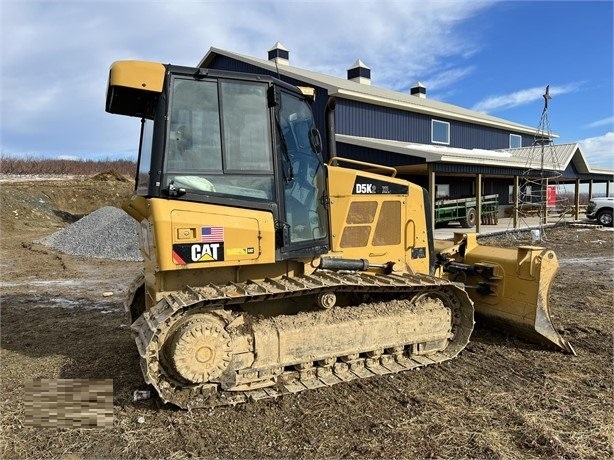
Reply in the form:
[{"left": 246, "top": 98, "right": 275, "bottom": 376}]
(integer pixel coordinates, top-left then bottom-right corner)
[{"left": 165, "top": 78, "right": 275, "bottom": 200}]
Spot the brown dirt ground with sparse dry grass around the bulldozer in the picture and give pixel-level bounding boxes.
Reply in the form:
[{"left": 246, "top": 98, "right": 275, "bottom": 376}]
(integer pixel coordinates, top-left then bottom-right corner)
[{"left": 0, "top": 176, "right": 614, "bottom": 459}]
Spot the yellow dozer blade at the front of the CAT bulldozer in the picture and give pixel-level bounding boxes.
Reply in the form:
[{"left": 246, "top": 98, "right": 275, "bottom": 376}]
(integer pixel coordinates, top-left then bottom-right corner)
[{"left": 437, "top": 233, "right": 576, "bottom": 355}]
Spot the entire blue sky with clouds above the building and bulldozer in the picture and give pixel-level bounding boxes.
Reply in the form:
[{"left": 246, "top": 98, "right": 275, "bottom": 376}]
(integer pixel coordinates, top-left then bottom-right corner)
[{"left": 0, "top": 0, "right": 614, "bottom": 168}]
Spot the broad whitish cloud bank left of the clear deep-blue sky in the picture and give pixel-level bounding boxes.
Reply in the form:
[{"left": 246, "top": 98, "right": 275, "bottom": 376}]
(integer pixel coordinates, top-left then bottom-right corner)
[{"left": 0, "top": 0, "right": 500, "bottom": 158}]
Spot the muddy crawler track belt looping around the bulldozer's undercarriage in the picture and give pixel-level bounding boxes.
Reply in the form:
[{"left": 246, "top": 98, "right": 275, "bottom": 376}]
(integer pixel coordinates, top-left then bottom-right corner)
[{"left": 131, "top": 271, "right": 473, "bottom": 409}]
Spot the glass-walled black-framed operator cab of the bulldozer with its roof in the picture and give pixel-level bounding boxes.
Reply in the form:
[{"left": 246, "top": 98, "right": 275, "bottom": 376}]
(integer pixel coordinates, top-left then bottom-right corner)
[{"left": 107, "top": 62, "right": 329, "bottom": 260}]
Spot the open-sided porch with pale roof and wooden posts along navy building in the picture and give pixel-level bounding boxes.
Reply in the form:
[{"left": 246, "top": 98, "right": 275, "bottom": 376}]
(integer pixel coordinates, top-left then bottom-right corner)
[{"left": 335, "top": 134, "right": 614, "bottom": 232}]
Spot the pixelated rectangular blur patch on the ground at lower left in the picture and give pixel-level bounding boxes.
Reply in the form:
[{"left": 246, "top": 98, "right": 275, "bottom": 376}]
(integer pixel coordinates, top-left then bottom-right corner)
[{"left": 25, "top": 379, "right": 113, "bottom": 428}]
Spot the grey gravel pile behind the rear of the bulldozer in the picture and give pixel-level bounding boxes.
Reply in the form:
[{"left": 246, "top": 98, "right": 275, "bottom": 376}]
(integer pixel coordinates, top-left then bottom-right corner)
[{"left": 37, "top": 206, "right": 143, "bottom": 261}]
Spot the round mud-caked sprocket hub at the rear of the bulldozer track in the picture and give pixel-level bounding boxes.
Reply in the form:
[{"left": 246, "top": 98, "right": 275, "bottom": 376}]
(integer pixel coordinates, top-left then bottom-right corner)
[{"left": 167, "top": 314, "right": 232, "bottom": 383}]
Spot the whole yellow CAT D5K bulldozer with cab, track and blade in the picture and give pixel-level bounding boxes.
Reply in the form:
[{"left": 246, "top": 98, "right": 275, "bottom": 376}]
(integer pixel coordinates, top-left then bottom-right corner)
[{"left": 106, "top": 61, "right": 573, "bottom": 408}]
